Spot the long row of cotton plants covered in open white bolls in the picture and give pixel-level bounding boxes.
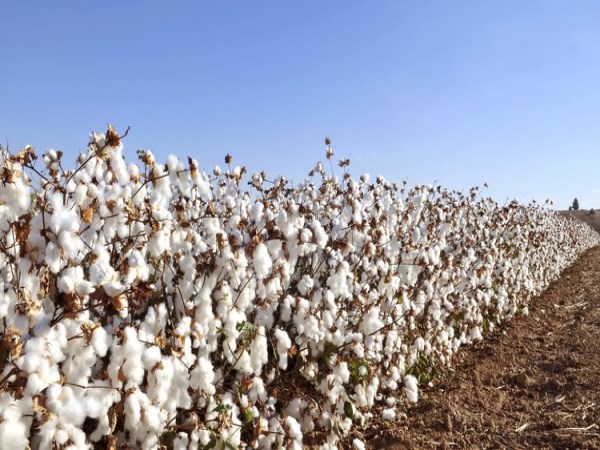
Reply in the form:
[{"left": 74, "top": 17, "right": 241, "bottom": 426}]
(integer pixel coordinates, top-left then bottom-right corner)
[{"left": 0, "top": 127, "right": 599, "bottom": 449}]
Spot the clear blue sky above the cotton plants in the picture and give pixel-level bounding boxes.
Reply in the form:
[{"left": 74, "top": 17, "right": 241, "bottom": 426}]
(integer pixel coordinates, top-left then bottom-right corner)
[{"left": 0, "top": 0, "right": 600, "bottom": 209}]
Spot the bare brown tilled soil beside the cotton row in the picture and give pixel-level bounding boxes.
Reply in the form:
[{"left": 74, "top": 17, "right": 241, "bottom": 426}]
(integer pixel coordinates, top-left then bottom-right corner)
[{"left": 364, "top": 247, "right": 600, "bottom": 450}]
